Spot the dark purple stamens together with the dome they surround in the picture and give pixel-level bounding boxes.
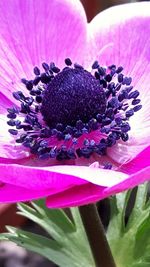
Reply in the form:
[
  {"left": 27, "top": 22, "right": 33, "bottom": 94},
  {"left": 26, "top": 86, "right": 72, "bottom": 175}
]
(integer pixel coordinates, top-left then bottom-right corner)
[{"left": 7, "top": 58, "right": 142, "bottom": 165}]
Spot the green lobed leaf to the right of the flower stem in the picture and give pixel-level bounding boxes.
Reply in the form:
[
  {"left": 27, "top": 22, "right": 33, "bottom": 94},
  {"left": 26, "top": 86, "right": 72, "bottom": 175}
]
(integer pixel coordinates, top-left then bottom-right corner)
[{"left": 107, "top": 183, "right": 150, "bottom": 267}]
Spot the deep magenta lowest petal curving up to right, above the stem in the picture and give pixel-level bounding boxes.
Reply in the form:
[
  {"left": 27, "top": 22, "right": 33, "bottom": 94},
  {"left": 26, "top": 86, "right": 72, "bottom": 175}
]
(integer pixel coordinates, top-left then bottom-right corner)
[{"left": 46, "top": 167, "right": 150, "bottom": 208}]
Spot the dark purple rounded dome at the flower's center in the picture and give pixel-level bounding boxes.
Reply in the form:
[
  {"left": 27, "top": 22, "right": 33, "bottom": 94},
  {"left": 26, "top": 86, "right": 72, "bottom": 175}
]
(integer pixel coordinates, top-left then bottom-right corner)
[{"left": 41, "top": 67, "right": 106, "bottom": 127}]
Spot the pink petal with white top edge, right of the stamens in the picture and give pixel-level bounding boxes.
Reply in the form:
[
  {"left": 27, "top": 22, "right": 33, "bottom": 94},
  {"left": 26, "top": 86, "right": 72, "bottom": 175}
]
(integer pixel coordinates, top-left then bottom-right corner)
[{"left": 87, "top": 2, "right": 150, "bottom": 163}]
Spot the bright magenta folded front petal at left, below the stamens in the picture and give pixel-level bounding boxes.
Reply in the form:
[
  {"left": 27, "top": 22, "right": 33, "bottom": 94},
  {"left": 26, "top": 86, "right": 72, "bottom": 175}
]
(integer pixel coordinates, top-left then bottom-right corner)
[{"left": 0, "top": 164, "right": 85, "bottom": 191}]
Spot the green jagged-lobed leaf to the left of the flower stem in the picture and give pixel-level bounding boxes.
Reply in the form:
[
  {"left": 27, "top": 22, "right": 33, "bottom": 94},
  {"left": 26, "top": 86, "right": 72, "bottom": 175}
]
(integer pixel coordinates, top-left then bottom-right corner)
[{"left": 0, "top": 200, "right": 95, "bottom": 267}]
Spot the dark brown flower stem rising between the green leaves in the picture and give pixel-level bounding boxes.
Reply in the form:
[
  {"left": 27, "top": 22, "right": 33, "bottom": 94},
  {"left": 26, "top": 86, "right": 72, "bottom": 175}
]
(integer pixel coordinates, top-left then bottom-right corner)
[{"left": 79, "top": 204, "right": 116, "bottom": 267}]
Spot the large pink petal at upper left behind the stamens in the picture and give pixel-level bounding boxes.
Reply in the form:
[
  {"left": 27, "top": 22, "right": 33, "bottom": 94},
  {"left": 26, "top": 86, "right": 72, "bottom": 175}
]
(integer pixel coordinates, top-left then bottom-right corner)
[{"left": 0, "top": 0, "right": 86, "bottom": 103}]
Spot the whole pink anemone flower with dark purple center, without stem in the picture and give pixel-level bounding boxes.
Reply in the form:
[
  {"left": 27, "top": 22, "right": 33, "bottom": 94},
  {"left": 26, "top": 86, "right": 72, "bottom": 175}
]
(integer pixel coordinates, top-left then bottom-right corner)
[{"left": 0, "top": 0, "right": 150, "bottom": 208}]
